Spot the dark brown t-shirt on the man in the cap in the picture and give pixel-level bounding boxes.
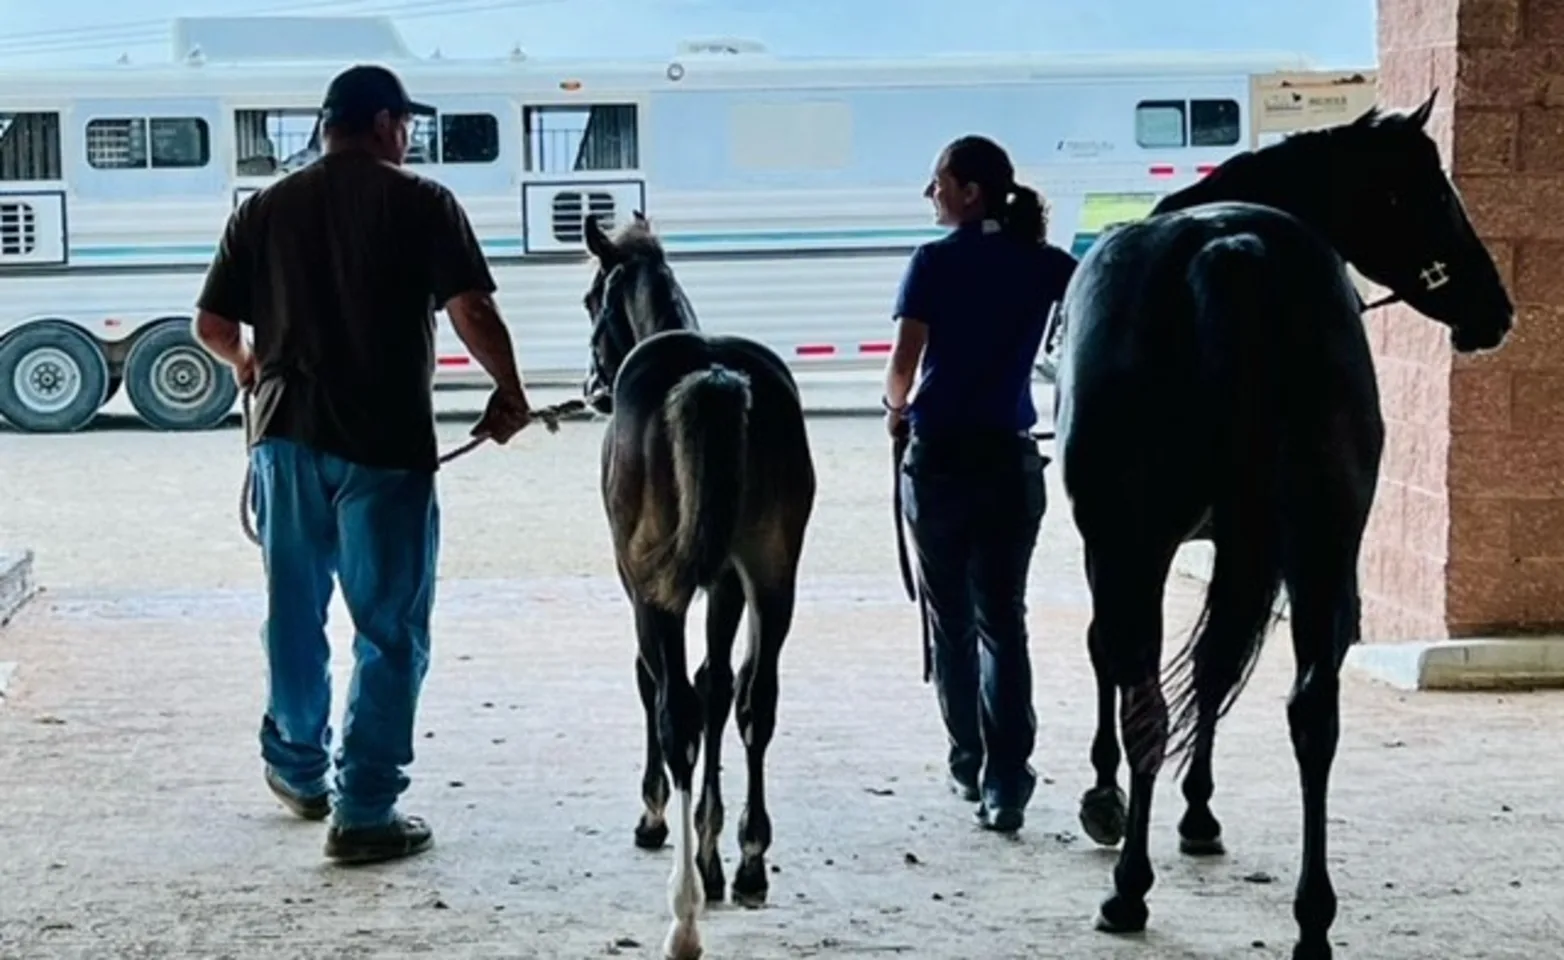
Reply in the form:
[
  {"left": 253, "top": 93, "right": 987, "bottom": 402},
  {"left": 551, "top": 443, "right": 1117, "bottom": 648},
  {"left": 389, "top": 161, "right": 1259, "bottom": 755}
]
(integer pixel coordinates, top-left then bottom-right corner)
[{"left": 197, "top": 152, "right": 494, "bottom": 471}]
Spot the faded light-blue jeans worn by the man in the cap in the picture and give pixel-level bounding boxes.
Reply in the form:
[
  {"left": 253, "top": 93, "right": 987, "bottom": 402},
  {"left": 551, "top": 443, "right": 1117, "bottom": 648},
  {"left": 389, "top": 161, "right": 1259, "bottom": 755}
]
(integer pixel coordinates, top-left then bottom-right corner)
[{"left": 250, "top": 439, "right": 439, "bottom": 827}]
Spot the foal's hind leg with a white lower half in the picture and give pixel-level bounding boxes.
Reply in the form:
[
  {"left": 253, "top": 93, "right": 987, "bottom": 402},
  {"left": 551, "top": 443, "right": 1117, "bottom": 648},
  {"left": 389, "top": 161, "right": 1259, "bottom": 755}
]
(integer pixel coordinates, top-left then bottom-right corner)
[{"left": 635, "top": 600, "right": 704, "bottom": 960}]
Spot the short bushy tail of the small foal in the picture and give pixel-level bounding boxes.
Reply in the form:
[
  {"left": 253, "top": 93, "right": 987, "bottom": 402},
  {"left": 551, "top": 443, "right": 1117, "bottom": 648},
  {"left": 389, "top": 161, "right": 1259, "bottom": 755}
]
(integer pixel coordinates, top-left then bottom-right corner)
[{"left": 647, "top": 364, "right": 751, "bottom": 610}]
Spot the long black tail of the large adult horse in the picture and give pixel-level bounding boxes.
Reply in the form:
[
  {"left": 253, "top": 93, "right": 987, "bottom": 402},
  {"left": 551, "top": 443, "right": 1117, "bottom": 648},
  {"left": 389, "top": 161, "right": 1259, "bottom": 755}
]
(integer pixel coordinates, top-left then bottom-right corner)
[{"left": 1164, "top": 233, "right": 1286, "bottom": 775}]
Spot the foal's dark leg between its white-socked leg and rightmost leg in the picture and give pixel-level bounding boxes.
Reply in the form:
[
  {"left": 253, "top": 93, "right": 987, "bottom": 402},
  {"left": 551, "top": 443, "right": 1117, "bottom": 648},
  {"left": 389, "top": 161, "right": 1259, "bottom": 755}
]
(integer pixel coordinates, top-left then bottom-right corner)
[{"left": 694, "top": 568, "right": 744, "bottom": 902}]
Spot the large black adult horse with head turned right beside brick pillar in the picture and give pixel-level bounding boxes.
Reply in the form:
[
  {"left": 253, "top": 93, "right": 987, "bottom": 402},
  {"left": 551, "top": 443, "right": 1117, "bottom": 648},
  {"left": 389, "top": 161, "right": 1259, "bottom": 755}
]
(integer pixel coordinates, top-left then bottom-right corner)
[{"left": 1056, "top": 97, "right": 1514, "bottom": 960}]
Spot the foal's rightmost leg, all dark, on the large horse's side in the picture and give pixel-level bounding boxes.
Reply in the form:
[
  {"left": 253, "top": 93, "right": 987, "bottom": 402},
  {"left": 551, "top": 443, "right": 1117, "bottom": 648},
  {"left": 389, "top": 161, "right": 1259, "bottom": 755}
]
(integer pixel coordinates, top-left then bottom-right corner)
[{"left": 734, "top": 574, "right": 795, "bottom": 907}]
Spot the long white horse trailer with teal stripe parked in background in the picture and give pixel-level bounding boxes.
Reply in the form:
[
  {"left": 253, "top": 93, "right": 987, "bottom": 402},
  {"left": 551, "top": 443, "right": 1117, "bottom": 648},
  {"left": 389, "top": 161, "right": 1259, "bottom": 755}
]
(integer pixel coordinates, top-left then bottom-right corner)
[{"left": 0, "top": 17, "right": 1308, "bottom": 432}]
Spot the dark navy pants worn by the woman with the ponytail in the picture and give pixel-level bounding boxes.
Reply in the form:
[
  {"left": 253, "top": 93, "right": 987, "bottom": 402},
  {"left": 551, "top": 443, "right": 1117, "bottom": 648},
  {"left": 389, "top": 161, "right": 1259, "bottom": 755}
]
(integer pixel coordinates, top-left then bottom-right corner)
[{"left": 901, "top": 432, "right": 1048, "bottom": 808}]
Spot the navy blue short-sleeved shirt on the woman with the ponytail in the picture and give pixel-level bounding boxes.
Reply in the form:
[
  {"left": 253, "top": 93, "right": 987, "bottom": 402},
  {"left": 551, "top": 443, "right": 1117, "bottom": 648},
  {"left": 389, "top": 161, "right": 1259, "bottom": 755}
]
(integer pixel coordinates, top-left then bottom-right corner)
[{"left": 895, "top": 220, "right": 1076, "bottom": 433}]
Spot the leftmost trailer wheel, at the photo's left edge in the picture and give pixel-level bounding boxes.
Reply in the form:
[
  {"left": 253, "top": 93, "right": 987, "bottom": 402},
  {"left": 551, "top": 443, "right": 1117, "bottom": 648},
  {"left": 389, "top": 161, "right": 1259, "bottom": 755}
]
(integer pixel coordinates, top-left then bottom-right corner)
[{"left": 0, "top": 321, "right": 108, "bottom": 433}]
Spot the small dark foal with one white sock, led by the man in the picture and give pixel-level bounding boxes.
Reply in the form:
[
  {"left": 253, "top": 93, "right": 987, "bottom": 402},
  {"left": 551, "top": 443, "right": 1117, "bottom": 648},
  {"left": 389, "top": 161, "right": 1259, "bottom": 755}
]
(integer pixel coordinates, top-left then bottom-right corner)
[{"left": 585, "top": 213, "right": 815, "bottom": 960}]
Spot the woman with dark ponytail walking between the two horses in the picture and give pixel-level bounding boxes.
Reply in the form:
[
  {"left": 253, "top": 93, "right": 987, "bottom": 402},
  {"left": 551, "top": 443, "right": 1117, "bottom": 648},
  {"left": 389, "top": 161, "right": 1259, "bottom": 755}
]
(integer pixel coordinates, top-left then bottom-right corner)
[{"left": 885, "top": 136, "right": 1076, "bottom": 832}]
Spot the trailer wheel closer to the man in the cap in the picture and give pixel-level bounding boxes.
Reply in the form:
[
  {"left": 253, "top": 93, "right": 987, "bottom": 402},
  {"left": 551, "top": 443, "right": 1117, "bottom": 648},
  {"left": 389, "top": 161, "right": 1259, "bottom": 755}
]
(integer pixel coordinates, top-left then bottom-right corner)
[{"left": 125, "top": 321, "right": 239, "bottom": 430}]
